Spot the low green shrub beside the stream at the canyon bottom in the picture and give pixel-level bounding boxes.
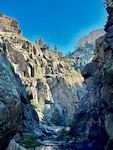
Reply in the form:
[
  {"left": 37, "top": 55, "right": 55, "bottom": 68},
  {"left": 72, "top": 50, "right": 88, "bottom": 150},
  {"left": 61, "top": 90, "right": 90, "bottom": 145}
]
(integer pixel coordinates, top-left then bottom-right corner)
[{"left": 20, "top": 135, "right": 41, "bottom": 148}]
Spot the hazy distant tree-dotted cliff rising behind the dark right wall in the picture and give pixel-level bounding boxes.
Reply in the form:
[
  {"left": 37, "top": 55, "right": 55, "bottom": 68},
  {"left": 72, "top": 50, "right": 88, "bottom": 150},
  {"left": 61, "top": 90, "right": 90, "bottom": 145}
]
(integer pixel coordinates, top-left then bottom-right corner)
[{"left": 71, "top": 28, "right": 105, "bottom": 70}]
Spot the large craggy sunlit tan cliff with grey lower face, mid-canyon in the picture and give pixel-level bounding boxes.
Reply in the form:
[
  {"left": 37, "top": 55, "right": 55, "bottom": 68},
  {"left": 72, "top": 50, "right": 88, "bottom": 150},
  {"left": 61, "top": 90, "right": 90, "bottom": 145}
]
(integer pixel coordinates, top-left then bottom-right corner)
[{"left": 0, "top": 14, "right": 86, "bottom": 130}]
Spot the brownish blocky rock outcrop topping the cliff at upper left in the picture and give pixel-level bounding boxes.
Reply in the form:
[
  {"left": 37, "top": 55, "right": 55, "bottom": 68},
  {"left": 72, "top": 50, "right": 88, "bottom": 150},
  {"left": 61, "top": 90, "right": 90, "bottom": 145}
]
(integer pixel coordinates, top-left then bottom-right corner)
[{"left": 0, "top": 14, "right": 21, "bottom": 34}]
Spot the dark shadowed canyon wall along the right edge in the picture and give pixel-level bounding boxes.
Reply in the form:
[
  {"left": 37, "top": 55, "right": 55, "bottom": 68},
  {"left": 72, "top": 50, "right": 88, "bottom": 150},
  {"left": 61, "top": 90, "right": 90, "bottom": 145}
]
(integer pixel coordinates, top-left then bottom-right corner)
[{"left": 73, "top": 1, "right": 113, "bottom": 150}]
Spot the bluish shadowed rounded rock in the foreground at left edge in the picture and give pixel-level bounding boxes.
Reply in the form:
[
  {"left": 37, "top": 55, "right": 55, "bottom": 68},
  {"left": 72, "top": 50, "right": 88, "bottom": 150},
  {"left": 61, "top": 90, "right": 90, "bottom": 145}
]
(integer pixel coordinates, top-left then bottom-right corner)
[{"left": 0, "top": 52, "right": 22, "bottom": 150}]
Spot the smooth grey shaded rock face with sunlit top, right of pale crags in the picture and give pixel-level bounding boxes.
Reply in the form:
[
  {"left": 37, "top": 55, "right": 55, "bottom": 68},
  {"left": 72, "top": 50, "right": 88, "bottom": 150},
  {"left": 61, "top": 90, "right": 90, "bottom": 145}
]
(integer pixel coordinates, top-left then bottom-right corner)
[{"left": 47, "top": 71, "right": 86, "bottom": 121}]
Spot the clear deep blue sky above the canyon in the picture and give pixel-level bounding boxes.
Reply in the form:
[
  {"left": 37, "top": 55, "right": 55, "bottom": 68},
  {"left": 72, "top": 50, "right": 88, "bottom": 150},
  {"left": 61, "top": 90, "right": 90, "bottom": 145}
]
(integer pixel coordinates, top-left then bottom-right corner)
[{"left": 0, "top": 0, "right": 107, "bottom": 54}]
